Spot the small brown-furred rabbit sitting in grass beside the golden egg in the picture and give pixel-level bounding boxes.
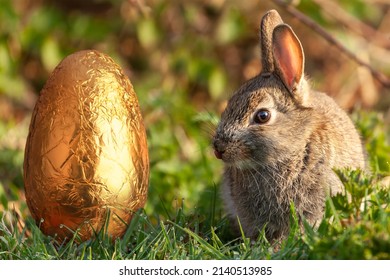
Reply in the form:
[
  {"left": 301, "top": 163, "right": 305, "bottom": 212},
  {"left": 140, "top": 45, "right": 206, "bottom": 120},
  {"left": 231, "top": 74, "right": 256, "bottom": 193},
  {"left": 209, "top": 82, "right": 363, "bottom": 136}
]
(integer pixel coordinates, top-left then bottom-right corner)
[{"left": 213, "top": 10, "right": 366, "bottom": 241}]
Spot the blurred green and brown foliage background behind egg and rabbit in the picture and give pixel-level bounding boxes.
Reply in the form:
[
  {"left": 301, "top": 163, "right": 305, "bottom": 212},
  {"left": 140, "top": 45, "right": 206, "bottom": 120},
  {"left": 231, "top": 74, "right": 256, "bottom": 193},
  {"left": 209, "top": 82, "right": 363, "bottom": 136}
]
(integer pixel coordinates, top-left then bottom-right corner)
[{"left": 0, "top": 0, "right": 390, "bottom": 225}]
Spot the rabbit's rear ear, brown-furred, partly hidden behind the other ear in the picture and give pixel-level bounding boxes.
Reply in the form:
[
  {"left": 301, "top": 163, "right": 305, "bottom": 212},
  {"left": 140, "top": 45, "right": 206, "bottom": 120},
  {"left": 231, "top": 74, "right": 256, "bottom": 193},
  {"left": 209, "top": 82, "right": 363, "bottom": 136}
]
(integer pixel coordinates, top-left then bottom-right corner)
[{"left": 260, "top": 10, "right": 283, "bottom": 72}]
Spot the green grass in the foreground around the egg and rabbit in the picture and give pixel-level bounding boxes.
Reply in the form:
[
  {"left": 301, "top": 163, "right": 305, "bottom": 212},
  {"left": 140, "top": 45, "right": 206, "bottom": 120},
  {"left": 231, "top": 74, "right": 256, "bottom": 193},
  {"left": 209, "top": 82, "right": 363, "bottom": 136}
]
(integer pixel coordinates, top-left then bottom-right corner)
[{"left": 0, "top": 113, "right": 390, "bottom": 259}]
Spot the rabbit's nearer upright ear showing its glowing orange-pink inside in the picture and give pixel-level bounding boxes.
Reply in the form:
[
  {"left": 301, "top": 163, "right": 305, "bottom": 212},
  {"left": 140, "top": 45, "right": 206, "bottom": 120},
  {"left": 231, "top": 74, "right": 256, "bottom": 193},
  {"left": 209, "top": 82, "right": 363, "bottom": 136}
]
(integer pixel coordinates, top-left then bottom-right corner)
[{"left": 272, "top": 24, "right": 305, "bottom": 92}]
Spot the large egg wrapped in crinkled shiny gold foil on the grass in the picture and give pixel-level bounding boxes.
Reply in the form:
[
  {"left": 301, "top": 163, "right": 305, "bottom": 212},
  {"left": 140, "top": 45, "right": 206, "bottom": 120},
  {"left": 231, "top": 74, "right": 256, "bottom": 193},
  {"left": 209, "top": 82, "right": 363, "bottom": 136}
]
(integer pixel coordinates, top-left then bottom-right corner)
[{"left": 24, "top": 50, "right": 149, "bottom": 241}]
